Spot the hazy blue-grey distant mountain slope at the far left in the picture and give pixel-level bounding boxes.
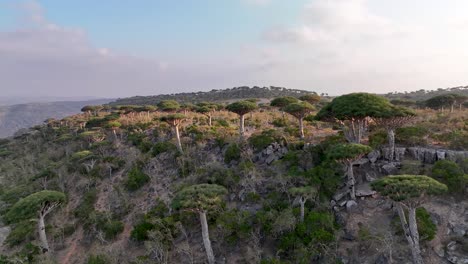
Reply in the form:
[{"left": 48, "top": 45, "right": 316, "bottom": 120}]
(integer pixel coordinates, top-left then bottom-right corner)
[{"left": 0, "top": 99, "right": 112, "bottom": 138}]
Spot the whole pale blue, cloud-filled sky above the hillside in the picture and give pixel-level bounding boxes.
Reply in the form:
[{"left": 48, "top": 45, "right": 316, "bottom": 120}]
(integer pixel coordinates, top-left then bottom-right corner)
[{"left": 0, "top": 0, "right": 468, "bottom": 98}]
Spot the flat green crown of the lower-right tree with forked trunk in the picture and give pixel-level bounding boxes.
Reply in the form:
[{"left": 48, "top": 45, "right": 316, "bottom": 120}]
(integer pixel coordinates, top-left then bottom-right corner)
[{"left": 371, "top": 175, "right": 447, "bottom": 202}]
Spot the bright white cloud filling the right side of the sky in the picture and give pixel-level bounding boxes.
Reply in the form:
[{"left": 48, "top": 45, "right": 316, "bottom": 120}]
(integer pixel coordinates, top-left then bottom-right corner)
[{"left": 263, "top": 0, "right": 468, "bottom": 94}]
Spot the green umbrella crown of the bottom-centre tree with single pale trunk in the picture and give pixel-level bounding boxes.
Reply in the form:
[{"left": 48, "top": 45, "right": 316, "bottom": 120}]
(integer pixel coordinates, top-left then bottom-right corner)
[{"left": 172, "top": 184, "right": 227, "bottom": 211}]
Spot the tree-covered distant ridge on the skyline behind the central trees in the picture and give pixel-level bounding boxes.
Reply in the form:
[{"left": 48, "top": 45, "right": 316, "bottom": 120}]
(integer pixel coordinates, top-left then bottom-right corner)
[{"left": 110, "top": 86, "right": 313, "bottom": 105}]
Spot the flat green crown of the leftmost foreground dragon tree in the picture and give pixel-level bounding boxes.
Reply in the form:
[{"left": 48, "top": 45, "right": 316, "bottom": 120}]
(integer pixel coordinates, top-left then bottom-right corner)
[{"left": 4, "top": 191, "right": 66, "bottom": 223}]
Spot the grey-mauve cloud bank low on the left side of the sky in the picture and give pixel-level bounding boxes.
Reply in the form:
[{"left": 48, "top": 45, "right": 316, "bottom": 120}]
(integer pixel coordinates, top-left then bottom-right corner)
[{"left": 0, "top": 1, "right": 260, "bottom": 97}]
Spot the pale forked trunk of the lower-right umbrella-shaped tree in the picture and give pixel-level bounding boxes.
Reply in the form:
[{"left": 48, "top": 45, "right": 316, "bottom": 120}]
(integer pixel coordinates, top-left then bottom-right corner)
[{"left": 397, "top": 203, "right": 423, "bottom": 264}]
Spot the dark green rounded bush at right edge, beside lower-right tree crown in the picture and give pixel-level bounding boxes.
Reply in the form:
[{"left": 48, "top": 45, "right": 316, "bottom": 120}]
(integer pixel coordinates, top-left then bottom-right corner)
[{"left": 431, "top": 160, "right": 468, "bottom": 193}]
